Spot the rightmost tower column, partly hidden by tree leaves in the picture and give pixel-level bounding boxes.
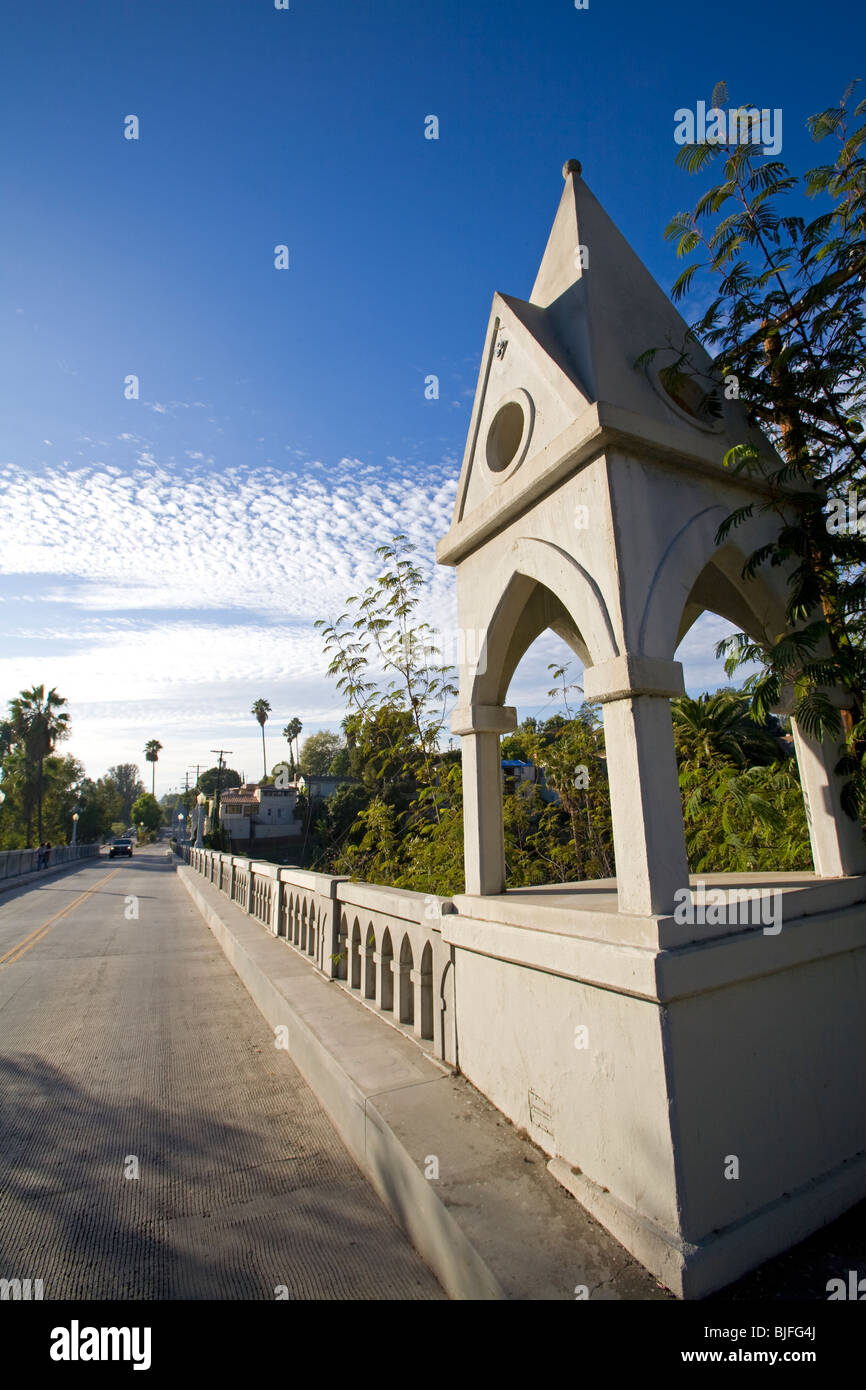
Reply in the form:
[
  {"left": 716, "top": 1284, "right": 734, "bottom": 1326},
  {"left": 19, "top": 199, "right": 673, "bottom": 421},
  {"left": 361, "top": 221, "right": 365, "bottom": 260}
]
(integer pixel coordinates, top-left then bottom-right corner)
[{"left": 791, "top": 719, "right": 866, "bottom": 878}]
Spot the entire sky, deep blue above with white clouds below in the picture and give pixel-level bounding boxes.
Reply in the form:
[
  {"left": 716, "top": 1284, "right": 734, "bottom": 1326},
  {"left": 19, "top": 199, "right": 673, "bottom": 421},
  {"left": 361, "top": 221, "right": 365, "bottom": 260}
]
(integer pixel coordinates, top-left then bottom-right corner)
[{"left": 0, "top": 0, "right": 863, "bottom": 791}]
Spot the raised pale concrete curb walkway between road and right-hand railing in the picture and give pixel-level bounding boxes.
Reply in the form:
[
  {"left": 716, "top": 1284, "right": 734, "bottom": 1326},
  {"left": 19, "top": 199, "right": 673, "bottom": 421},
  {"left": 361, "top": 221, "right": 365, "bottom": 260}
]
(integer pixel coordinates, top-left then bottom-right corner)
[{"left": 177, "top": 866, "right": 666, "bottom": 1300}]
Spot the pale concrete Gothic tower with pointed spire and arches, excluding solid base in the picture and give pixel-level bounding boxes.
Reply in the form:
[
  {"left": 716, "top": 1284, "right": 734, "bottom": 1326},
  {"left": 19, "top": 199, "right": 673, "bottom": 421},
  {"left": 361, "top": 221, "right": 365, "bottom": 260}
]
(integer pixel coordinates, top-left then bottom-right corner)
[{"left": 436, "top": 160, "right": 866, "bottom": 916}]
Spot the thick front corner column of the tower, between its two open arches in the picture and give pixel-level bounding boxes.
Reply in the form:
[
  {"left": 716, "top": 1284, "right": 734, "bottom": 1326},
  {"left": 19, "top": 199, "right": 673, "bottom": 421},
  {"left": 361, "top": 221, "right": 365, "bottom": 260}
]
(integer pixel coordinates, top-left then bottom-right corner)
[{"left": 584, "top": 656, "right": 688, "bottom": 916}]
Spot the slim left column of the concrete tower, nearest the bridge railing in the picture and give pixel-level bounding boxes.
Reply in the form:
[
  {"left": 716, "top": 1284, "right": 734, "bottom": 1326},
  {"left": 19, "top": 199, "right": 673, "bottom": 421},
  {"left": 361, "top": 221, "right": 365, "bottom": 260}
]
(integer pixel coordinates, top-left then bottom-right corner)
[{"left": 452, "top": 705, "right": 517, "bottom": 894}]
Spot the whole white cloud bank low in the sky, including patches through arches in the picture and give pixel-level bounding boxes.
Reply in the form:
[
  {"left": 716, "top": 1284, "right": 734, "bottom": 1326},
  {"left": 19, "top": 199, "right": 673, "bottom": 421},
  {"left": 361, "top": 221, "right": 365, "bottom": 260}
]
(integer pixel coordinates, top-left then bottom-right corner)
[{"left": 0, "top": 448, "right": 727, "bottom": 781}]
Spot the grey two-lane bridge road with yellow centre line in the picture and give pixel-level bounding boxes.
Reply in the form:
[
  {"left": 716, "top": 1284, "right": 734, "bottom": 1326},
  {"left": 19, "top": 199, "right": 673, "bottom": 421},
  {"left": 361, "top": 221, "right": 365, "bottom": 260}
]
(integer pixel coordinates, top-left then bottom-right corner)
[{"left": 0, "top": 845, "right": 445, "bottom": 1300}]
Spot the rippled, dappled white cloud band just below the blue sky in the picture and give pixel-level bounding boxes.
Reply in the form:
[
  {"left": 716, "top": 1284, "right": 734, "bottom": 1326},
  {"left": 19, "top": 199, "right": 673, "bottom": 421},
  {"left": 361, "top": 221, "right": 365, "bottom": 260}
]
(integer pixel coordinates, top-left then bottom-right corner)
[{"left": 0, "top": 457, "right": 456, "bottom": 619}]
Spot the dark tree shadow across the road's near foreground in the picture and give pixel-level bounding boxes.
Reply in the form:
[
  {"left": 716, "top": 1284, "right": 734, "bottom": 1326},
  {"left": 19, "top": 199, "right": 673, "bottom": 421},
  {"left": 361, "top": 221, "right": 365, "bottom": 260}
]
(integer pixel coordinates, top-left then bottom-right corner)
[{"left": 0, "top": 1054, "right": 443, "bottom": 1300}]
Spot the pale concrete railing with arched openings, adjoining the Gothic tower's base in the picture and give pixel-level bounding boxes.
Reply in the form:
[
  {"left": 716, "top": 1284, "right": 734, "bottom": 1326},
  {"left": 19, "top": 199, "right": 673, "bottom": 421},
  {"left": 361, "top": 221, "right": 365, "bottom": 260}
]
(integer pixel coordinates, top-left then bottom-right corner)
[{"left": 182, "top": 845, "right": 457, "bottom": 1063}]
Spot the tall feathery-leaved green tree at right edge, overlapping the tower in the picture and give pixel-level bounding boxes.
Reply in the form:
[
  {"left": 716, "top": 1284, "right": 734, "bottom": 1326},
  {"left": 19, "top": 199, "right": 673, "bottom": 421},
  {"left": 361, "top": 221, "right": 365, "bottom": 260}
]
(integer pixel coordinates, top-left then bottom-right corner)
[{"left": 656, "top": 83, "right": 866, "bottom": 817}]
